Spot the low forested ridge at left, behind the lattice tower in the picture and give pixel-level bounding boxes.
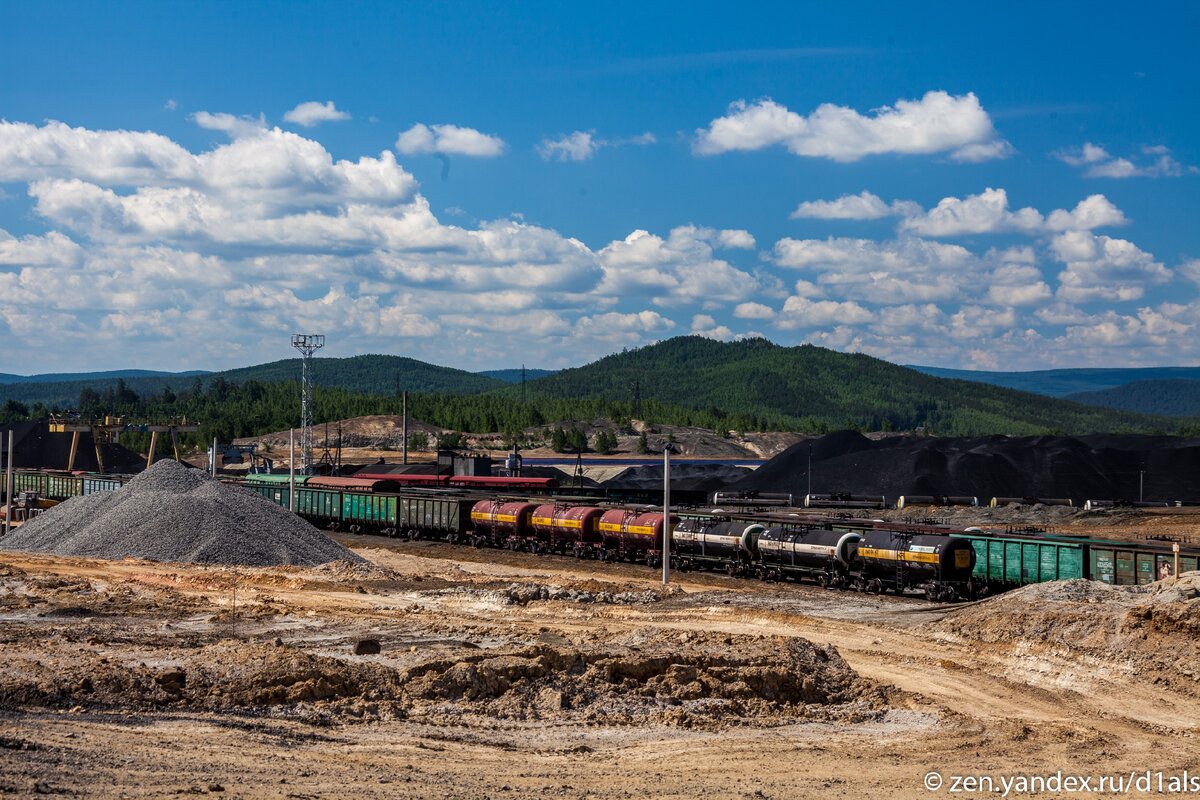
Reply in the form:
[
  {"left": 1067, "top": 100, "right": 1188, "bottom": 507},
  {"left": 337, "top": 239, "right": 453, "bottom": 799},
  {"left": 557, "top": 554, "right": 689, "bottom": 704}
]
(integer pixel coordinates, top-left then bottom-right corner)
[{"left": 0, "top": 355, "right": 506, "bottom": 409}]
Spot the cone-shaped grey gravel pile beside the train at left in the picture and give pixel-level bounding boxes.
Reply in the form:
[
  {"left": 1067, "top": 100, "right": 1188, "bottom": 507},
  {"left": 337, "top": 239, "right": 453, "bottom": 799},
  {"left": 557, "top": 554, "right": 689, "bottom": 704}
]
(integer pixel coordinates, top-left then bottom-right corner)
[{"left": 0, "top": 461, "right": 362, "bottom": 566}]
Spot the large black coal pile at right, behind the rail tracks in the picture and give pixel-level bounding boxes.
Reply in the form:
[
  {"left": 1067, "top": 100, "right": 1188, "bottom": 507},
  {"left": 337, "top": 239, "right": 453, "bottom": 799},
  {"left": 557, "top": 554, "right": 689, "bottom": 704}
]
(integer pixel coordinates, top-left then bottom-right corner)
[{"left": 726, "top": 431, "right": 1200, "bottom": 503}]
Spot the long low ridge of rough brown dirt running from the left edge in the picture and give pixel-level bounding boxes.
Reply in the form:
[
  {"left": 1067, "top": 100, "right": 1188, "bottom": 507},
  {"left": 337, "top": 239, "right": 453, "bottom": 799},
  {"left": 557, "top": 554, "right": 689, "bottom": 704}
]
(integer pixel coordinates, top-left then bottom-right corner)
[{"left": 0, "top": 628, "right": 886, "bottom": 727}]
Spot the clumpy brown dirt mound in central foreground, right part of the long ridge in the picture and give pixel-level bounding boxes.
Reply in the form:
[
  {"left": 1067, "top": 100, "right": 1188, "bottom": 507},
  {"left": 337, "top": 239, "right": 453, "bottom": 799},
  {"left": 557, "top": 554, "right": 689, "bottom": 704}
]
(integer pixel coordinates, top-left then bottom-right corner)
[{"left": 388, "top": 628, "right": 886, "bottom": 726}]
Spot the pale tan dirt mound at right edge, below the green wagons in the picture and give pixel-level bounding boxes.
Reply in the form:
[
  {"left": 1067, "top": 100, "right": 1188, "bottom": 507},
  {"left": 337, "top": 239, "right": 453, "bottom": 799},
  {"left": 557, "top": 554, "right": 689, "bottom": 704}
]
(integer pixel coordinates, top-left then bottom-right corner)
[{"left": 936, "top": 572, "right": 1200, "bottom": 696}]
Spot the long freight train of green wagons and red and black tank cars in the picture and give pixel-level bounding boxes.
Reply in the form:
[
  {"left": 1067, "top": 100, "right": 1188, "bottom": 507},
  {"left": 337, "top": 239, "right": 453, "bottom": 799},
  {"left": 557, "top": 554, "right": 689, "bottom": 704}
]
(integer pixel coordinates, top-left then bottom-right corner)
[{"left": 4, "top": 473, "right": 1200, "bottom": 600}]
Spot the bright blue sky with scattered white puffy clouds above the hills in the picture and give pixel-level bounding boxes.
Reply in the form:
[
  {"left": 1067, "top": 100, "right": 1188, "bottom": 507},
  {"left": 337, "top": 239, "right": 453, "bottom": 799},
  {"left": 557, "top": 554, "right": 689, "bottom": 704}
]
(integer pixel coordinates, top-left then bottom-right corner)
[{"left": 0, "top": 2, "right": 1200, "bottom": 373}]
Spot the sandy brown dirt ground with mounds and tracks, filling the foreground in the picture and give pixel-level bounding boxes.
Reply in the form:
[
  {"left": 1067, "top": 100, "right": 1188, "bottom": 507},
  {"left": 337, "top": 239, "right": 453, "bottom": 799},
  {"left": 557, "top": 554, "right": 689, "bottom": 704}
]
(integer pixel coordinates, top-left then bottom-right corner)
[{"left": 0, "top": 536, "right": 1200, "bottom": 800}]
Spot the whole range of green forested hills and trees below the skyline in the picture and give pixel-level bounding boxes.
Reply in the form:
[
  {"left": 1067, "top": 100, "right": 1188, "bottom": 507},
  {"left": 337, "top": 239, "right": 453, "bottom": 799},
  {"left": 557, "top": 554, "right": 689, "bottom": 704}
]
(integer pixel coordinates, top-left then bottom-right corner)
[{"left": 0, "top": 337, "right": 1180, "bottom": 444}]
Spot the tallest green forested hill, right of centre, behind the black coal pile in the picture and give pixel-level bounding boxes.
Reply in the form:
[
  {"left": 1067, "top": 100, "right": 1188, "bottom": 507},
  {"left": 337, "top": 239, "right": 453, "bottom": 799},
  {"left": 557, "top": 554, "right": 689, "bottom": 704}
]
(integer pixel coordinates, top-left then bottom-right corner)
[{"left": 511, "top": 336, "right": 1177, "bottom": 435}]
